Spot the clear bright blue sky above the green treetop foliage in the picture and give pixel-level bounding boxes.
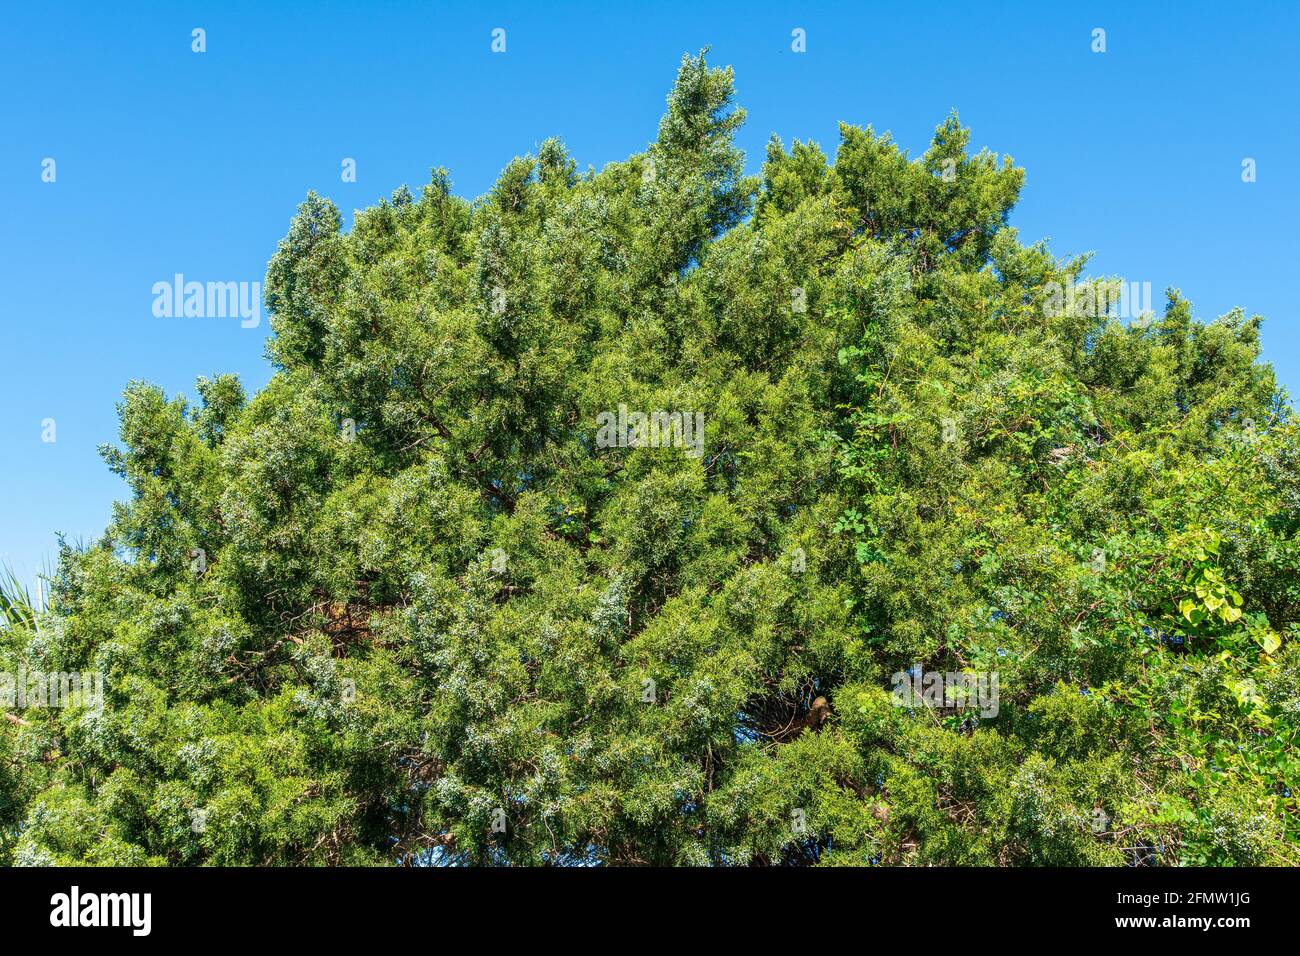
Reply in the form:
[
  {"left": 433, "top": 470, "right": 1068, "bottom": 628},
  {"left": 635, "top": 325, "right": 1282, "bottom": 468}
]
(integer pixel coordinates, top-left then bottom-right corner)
[{"left": 0, "top": 0, "right": 1300, "bottom": 590}]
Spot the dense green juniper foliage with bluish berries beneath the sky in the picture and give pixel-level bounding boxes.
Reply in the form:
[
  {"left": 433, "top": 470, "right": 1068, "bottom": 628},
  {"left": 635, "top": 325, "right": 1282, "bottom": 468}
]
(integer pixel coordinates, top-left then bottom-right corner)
[{"left": 0, "top": 56, "right": 1300, "bottom": 865}]
